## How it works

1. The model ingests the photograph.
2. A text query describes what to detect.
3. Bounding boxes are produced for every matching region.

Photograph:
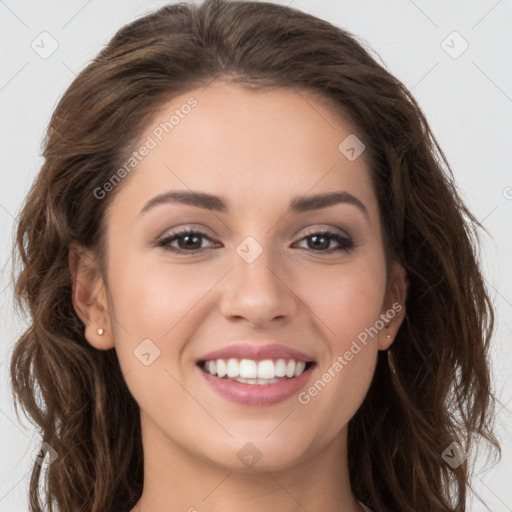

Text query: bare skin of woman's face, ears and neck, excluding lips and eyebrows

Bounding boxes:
[70,81,407,512]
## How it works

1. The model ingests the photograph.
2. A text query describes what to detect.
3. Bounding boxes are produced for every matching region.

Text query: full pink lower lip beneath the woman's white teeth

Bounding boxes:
[197,364,315,405]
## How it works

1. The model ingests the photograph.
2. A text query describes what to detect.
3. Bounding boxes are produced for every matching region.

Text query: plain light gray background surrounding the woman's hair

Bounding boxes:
[0,0,512,512]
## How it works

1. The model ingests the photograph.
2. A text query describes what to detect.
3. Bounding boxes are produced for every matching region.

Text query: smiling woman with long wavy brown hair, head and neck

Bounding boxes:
[11,0,498,512]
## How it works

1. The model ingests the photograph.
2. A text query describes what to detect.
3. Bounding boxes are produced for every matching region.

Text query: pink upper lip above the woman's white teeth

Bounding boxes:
[197,341,314,363]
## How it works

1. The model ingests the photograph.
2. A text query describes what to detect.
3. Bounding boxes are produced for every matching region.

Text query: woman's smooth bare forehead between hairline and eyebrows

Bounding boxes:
[106,81,375,220]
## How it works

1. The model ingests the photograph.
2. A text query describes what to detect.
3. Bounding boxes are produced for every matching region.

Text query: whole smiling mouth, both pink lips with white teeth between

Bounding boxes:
[197,341,315,405]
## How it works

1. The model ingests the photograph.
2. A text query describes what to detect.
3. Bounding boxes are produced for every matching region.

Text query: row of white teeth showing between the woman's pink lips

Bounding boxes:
[203,358,306,384]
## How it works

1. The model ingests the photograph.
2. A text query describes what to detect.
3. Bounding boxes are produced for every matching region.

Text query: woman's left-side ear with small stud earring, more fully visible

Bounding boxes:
[69,244,114,350]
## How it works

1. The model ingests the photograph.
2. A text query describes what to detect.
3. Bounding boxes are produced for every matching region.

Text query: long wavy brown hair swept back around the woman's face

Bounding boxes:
[11,0,499,512]
